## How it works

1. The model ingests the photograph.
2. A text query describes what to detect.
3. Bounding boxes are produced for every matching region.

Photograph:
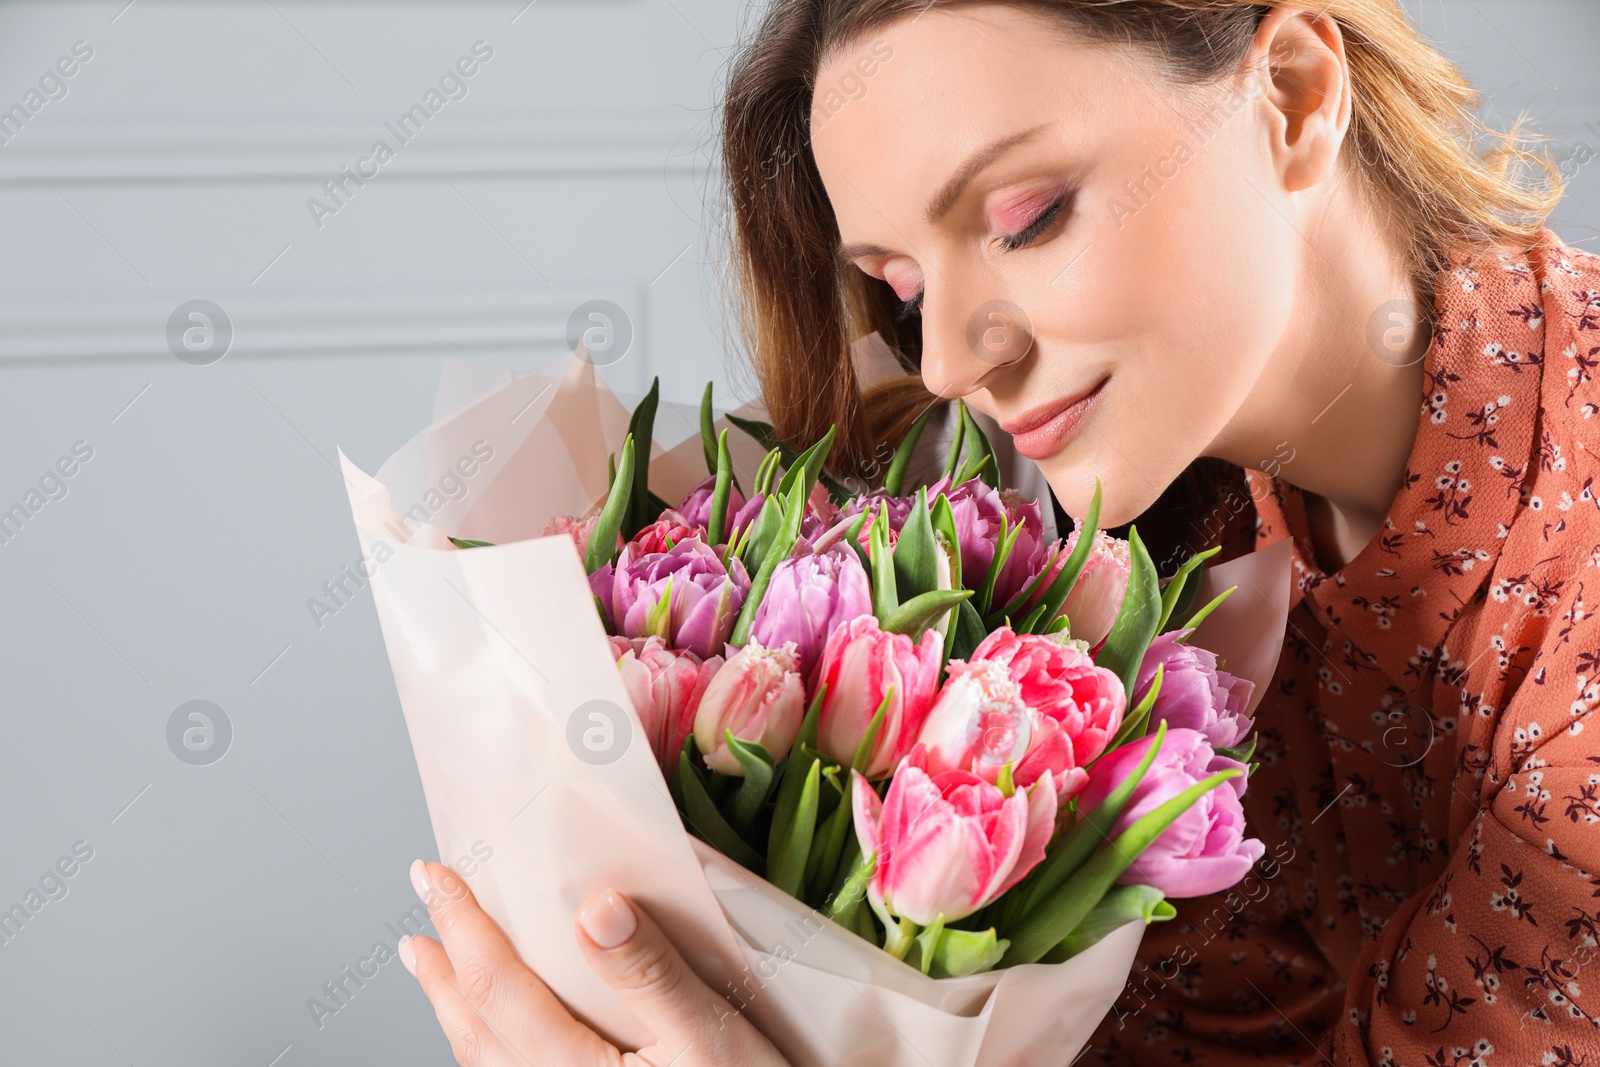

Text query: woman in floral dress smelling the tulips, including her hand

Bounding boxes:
[393,0,1600,1067]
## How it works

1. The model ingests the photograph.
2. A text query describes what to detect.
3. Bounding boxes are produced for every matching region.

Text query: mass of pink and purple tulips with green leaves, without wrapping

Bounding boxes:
[508,382,1264,977]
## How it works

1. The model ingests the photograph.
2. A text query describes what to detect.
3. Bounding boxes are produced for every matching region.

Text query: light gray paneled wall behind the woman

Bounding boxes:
[0,0,1600,1067]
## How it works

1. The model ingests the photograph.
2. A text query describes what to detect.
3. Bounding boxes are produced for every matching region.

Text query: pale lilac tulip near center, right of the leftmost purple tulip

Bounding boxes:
[750,541,872,680]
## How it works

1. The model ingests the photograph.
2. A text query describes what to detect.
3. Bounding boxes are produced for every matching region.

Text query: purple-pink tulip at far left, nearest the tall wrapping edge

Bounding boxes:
[589,537,750,659]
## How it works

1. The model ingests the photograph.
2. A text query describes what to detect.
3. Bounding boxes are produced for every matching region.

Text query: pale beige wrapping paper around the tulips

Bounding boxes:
[341,357,1288,1067]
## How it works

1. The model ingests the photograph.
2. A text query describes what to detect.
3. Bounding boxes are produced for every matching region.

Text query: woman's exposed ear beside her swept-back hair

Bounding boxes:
[1248,8,1350,192]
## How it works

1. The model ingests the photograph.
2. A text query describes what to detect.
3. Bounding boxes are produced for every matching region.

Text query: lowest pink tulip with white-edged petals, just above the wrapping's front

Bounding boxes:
[851,745,1056,926]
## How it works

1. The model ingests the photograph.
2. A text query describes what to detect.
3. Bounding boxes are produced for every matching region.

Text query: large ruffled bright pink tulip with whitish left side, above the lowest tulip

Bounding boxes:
[918,627,1126,803]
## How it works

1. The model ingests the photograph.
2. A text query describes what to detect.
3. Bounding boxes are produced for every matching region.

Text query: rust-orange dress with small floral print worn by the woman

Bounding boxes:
[1085,232,1600,1067]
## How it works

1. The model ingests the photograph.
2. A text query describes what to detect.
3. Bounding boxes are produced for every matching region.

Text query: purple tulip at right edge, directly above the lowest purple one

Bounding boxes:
[1128,630,1256,749]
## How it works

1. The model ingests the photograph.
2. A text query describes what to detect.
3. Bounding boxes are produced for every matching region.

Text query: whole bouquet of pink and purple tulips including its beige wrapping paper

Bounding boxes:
[344,352,1288,1067]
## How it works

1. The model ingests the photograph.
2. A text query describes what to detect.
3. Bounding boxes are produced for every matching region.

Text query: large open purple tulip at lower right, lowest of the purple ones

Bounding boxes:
[1078,729,1266,897]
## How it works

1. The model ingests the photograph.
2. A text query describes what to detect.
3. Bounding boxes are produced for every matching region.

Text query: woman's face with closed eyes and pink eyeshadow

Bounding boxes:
[811,3,1304,526]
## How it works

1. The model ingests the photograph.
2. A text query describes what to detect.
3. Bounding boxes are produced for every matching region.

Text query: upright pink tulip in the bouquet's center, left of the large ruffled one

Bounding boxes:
[818,614,944,779]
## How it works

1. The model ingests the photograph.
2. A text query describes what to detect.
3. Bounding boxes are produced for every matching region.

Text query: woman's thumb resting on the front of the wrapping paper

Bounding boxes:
[578,889,754,1064]
